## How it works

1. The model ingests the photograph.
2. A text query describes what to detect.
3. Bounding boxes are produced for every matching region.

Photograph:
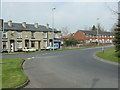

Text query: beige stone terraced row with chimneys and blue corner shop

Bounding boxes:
[2,21,61,52]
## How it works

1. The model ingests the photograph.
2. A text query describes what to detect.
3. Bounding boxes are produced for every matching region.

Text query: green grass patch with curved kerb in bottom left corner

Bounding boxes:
[2,59,27,88]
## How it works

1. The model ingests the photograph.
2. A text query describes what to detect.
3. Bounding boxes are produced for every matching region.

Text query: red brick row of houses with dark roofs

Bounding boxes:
[61,30,114,44]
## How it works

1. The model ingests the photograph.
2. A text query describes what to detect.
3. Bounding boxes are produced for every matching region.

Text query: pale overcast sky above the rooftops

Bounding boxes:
[2,2,117,32]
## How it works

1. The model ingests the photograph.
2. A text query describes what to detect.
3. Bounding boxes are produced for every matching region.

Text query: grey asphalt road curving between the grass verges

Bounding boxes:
[3,46,119,88]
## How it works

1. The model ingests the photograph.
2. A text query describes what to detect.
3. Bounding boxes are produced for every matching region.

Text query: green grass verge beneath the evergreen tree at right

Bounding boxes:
[96,48,118,63]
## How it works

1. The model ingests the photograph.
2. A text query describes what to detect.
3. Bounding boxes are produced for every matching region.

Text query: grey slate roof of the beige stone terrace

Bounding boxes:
[4,22,60,32]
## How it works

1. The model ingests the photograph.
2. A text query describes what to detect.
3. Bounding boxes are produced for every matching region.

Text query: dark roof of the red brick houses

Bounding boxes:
[79,30,114,35]
